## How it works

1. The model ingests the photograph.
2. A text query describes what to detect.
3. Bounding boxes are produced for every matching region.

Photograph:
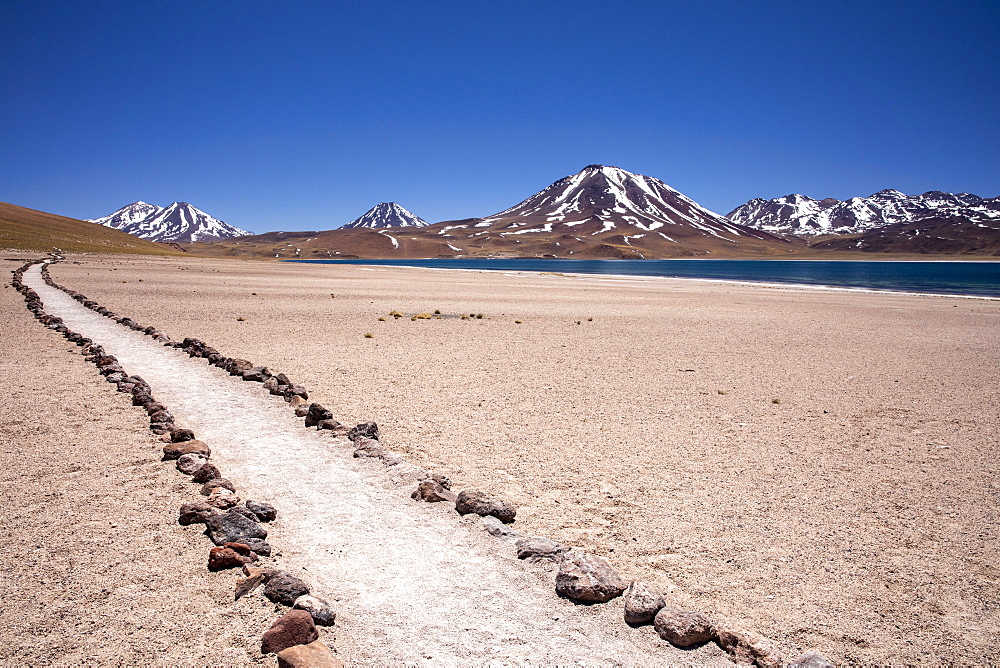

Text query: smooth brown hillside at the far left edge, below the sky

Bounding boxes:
[0,202,184,255]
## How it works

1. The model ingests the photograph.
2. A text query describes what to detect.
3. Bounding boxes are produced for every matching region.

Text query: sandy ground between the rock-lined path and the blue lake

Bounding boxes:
[5,253,1000,663]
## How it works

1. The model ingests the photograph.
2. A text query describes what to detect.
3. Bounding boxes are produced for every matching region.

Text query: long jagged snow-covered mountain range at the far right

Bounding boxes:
[727,190,1000,236]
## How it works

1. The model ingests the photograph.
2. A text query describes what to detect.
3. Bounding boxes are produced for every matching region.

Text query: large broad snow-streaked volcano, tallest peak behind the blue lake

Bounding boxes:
[458,165,772,245]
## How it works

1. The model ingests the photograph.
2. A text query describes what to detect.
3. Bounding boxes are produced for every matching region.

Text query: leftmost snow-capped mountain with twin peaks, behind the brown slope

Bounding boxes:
[90,202,250,242]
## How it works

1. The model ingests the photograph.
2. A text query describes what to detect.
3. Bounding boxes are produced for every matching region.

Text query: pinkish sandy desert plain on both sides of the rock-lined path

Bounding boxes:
[0,252,1000,664]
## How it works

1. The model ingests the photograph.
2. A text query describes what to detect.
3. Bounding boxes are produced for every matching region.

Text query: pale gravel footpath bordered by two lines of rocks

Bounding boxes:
[24,267,725,665]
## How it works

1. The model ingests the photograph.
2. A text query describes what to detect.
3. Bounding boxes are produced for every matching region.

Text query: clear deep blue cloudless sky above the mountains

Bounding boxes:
[0,0,1000,232]
